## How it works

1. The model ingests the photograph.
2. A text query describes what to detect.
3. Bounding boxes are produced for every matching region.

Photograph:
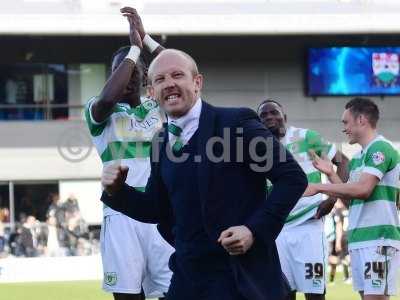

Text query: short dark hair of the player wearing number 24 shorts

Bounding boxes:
[345,97,379,128]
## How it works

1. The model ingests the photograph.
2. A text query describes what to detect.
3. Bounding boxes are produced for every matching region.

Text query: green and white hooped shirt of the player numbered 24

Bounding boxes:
[348,136,400,250]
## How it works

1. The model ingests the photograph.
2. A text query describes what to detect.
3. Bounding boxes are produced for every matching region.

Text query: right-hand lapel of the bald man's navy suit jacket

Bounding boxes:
[197,101,215,205]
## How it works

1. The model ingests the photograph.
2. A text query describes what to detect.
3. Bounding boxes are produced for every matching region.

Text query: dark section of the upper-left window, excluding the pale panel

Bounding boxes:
[0,63,68,120]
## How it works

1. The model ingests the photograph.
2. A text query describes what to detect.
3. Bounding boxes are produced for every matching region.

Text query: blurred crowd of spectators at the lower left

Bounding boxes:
[0,194,99,258]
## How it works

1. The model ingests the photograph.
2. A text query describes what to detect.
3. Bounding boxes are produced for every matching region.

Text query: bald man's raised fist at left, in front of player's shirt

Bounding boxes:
[101,164,129,195]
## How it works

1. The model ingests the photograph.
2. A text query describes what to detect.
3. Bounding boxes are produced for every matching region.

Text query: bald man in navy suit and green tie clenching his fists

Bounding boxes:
[102,43,307,300]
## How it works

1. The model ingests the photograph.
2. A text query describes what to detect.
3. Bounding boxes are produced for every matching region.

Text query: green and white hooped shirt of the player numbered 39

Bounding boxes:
[281,126,336,228]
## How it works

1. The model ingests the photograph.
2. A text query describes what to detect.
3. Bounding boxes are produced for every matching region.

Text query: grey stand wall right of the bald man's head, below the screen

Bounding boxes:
[199,61,400,142]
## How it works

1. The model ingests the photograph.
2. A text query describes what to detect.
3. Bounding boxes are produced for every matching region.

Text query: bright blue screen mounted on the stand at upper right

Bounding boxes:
[307,47,400,96]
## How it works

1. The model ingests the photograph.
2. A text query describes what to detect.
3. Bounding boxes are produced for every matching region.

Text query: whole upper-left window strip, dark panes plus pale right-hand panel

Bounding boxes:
[0,63,106,120]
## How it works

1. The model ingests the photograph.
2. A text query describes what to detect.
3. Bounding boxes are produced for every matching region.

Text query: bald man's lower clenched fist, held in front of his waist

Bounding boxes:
[218,225,254,255]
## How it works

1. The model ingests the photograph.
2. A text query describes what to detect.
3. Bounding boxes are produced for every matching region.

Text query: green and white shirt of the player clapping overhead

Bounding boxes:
[85,97,163,216]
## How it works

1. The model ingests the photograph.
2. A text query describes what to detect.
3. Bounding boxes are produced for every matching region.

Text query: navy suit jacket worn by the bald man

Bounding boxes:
[102,102,307,300]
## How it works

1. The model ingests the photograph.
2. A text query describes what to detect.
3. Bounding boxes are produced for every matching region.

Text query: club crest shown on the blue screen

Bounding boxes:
[372,52,400,87]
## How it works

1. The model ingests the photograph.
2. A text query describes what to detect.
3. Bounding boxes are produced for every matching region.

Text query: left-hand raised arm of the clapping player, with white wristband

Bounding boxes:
[92,10,143,123]
